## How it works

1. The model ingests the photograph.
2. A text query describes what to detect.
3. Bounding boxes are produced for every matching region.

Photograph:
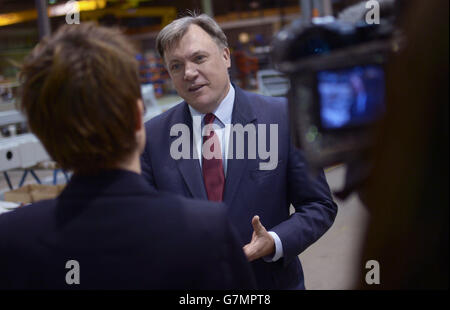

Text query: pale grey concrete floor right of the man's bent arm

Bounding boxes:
[299,167,369,290]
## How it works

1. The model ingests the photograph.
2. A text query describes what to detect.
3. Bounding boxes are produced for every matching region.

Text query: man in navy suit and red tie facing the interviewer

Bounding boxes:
[141,15,337,289]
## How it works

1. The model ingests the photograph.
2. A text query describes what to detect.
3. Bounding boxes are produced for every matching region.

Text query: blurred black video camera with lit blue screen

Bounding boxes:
[272,0,401,198]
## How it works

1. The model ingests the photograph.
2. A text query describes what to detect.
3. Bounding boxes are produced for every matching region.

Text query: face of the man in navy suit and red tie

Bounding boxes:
[164,25,231,113]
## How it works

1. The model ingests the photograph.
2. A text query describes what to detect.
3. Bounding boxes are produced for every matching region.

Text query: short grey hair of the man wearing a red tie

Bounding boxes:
[156,13,228,59]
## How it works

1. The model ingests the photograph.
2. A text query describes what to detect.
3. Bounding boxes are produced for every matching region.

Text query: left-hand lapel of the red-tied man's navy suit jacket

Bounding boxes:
[171,102,208,200]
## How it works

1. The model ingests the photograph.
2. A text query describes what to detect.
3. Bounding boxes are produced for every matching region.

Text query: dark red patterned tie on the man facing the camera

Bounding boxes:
[202,113,225,201]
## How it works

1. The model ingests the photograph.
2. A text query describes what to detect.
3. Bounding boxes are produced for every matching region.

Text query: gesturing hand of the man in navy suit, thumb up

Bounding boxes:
[243,215,275,262]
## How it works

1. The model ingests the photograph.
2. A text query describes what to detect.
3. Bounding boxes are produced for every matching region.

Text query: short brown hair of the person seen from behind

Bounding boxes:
[21,23,141,173]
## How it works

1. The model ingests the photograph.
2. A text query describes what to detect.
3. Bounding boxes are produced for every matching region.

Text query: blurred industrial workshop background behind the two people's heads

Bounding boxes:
[0,0,366,189]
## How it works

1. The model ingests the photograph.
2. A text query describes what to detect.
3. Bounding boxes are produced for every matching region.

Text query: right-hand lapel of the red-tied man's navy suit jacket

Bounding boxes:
[224,85,256,205]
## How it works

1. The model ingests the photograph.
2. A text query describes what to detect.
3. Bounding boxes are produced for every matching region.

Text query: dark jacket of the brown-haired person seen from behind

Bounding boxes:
[0,170,254,289]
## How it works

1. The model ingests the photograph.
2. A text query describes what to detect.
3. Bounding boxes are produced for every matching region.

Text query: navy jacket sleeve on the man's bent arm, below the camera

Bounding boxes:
[271,131,337,265]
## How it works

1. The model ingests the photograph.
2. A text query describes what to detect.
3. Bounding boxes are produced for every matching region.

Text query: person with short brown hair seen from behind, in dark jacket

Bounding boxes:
[0,23,254,289]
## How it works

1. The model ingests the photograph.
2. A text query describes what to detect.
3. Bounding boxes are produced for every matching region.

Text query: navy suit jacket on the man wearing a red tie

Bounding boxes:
[141,86,337,289]
